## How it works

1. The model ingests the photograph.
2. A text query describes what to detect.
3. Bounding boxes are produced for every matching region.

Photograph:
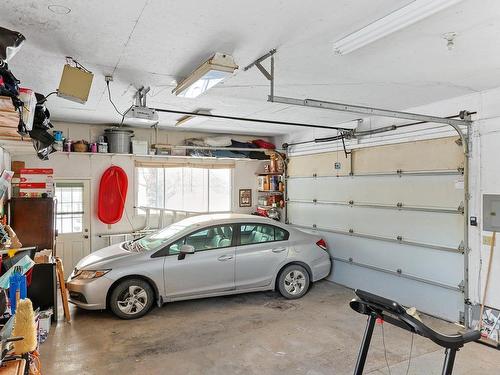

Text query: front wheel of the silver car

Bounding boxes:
[109,279,154,319]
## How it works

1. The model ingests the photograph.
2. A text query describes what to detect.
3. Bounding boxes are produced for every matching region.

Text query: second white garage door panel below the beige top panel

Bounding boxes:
[288,202,463,248]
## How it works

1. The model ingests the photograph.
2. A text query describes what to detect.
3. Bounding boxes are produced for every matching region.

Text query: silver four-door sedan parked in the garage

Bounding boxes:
[67,214,331,319]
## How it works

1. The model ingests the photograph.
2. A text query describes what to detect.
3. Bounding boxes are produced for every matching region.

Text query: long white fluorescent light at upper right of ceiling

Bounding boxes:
[333,0,462,55]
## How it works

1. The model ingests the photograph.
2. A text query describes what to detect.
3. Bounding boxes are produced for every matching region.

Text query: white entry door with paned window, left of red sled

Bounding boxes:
[55,180,90,276]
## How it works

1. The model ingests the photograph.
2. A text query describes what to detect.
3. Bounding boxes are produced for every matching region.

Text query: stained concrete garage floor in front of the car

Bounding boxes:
[41,281,500,375]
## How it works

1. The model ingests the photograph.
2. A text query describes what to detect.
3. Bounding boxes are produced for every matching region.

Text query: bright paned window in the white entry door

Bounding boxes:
[55,182,84,233]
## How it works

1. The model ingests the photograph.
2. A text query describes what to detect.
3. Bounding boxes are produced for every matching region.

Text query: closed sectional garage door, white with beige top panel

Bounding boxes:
[287,137,464,321]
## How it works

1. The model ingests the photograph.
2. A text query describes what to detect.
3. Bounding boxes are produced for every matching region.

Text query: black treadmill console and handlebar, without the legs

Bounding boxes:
[349,289,481,349]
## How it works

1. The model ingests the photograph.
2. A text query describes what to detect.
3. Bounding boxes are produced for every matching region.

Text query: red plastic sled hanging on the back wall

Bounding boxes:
[97,166,128,224]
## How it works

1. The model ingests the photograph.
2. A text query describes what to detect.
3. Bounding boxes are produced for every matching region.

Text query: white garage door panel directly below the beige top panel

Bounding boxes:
[288,175,463,209]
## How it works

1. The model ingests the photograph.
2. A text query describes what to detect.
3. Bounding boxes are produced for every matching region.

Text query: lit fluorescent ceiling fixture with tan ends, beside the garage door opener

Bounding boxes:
[172,53,238,98]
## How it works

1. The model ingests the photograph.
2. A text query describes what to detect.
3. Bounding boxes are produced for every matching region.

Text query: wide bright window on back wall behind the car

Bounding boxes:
[136,167,232,212]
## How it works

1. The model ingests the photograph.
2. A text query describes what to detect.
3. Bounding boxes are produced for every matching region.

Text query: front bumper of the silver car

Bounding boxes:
[66,276,113,310]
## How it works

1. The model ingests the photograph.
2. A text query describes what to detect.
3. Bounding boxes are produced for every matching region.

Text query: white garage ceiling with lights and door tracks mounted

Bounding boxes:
[0,0,500,135]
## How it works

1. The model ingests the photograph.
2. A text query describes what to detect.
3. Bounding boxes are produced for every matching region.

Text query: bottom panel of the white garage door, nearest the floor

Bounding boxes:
[332,262,463,321]
